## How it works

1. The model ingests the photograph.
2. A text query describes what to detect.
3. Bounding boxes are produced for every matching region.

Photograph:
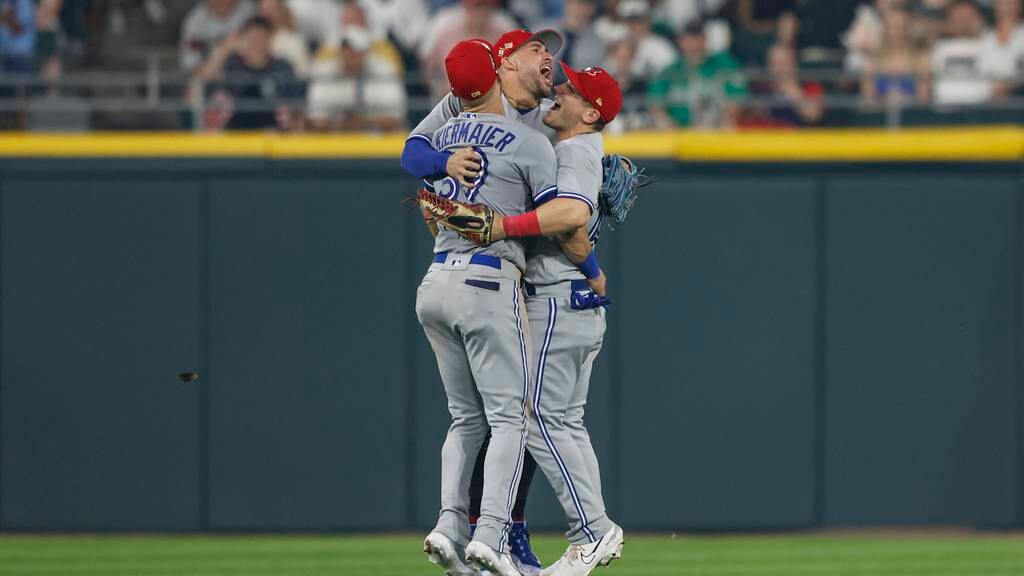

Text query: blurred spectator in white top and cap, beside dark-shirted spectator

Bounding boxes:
[309,27,406,130]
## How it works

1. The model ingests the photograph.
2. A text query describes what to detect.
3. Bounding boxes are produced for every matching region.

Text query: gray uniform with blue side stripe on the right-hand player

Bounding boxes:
[525,134,613,543]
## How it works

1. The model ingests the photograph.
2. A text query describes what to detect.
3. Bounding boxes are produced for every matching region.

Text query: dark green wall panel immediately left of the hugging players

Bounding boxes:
[210,176,411,530]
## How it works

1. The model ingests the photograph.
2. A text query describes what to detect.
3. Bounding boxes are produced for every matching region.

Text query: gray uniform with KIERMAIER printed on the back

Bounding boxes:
[416,113,556,552]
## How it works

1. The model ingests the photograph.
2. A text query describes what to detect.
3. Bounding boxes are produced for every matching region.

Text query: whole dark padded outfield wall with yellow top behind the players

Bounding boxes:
[0,128,1024,531]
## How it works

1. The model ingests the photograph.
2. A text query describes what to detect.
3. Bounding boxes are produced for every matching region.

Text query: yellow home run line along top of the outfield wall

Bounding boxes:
[0,126,1024,162]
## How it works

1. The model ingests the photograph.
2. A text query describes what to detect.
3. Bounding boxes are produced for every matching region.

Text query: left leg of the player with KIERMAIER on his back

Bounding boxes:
[417,272,487,575]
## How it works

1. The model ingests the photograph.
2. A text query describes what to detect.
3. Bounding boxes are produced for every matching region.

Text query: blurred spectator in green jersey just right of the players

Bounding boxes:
[647,23,746,128]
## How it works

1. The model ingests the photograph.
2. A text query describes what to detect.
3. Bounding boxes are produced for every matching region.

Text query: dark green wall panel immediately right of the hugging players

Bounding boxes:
[610,173,815,529]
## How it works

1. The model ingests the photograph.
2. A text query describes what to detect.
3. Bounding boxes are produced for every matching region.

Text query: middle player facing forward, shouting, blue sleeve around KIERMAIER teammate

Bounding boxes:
[401,30,565,576]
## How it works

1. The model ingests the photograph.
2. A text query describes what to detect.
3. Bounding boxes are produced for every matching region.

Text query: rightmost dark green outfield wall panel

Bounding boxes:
[824,171,1021,526]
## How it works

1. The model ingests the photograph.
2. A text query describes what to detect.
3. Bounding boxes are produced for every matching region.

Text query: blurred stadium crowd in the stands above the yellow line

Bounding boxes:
[0,0,1024,130]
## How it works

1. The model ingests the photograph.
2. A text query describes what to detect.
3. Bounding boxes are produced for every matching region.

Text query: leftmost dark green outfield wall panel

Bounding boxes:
[0,178,202,531]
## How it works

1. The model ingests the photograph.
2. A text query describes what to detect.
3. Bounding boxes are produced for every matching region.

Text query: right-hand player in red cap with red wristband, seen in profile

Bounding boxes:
[417,65,623,576]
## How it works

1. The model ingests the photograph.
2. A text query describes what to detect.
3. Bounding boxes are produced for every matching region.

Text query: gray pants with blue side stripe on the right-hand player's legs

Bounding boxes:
[527,297,614,544]
